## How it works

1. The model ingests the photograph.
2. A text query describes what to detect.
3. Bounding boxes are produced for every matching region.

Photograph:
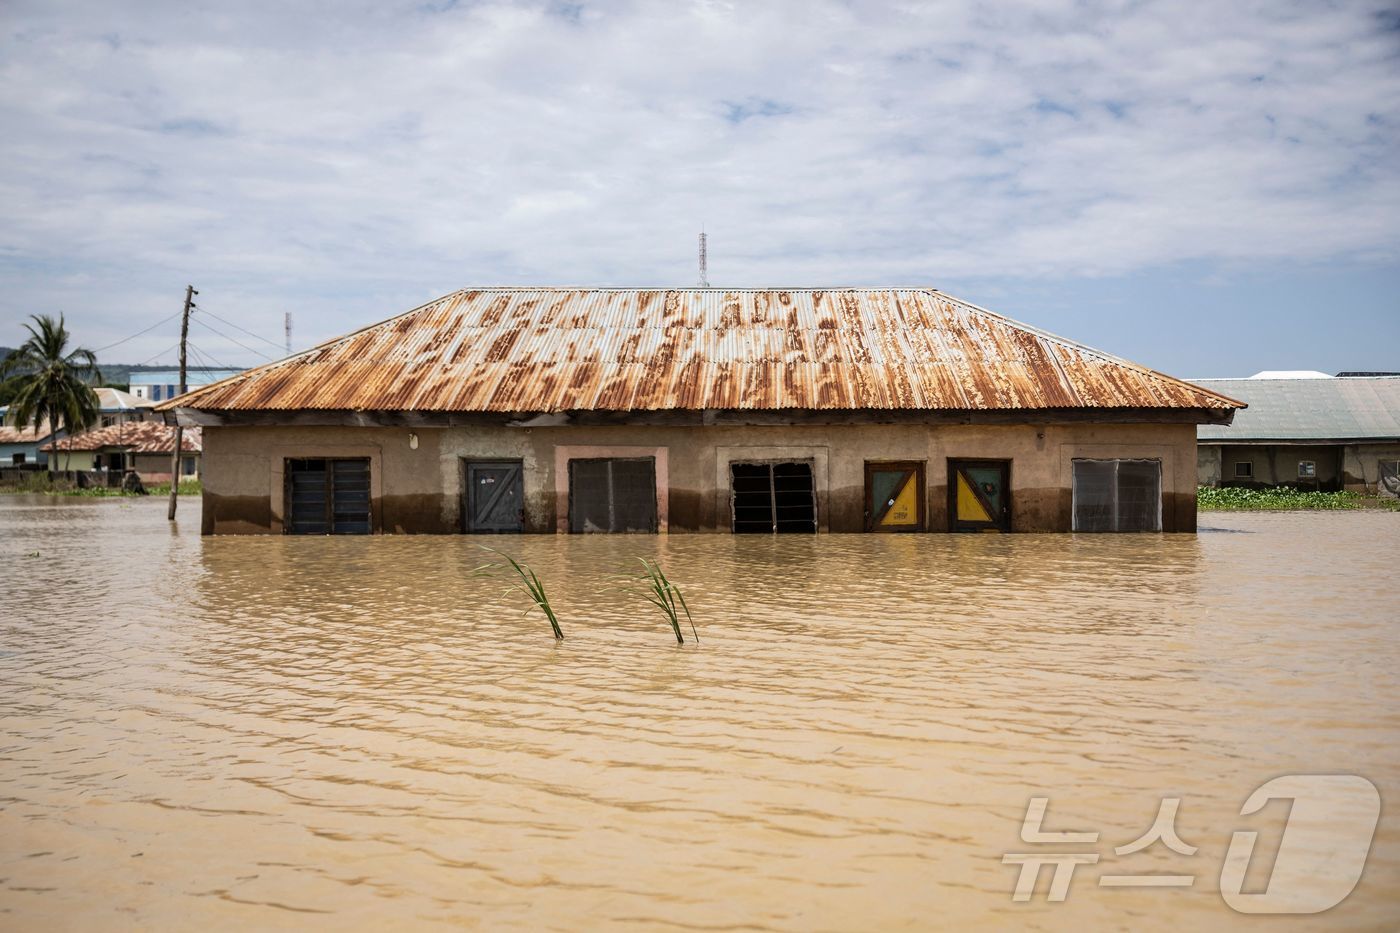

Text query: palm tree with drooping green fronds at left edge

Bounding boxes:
[0,314,102,471]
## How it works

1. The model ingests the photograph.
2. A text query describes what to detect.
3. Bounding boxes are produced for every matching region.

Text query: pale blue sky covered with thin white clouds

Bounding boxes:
[0,0,1400,377]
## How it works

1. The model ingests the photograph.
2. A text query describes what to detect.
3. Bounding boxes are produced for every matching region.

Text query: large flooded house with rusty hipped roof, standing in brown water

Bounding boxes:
[158,287,1242,534]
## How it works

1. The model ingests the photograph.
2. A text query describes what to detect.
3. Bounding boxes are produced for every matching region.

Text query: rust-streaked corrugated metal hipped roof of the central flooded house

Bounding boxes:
[160,289,1236,412]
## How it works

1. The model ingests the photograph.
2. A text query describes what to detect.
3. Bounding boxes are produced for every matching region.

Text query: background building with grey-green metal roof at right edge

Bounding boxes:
[1196,373,1400,496]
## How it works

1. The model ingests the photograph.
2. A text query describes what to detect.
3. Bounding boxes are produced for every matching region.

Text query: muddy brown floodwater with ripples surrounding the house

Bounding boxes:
[0,496,1400,930]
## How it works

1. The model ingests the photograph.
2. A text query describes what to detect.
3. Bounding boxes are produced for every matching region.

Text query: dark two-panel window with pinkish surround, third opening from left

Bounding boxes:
[568,457,657,534]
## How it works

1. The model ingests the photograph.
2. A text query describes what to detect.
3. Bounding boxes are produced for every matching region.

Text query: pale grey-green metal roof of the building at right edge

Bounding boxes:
[1197,375,1400,444]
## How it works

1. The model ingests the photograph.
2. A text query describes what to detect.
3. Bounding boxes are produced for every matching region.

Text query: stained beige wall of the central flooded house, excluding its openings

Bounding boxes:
[202,424,1197,534]
